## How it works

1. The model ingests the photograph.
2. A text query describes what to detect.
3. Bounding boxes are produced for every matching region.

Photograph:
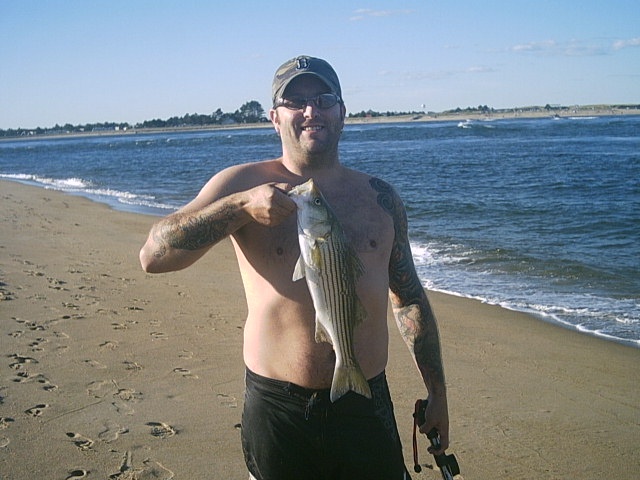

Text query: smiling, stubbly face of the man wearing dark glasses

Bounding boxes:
[269,75,345,158]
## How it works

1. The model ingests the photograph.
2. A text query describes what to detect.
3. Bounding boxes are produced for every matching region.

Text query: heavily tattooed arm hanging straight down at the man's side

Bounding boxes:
[371,179,449,453]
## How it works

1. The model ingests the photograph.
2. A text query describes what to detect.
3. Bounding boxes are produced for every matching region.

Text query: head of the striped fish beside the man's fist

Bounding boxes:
[289,179,335,238]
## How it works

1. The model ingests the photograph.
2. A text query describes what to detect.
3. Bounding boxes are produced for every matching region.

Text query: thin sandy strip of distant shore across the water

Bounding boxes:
[0,105,640,142]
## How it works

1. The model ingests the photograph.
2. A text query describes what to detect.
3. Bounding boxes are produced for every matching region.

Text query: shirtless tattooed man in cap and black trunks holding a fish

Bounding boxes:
[140,56,449,480]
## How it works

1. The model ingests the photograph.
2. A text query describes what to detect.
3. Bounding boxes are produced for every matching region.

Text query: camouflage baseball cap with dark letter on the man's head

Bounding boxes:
[271,55,342,105]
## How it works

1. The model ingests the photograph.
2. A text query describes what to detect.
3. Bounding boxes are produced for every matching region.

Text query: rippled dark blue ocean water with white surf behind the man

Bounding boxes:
[0,116,640,347]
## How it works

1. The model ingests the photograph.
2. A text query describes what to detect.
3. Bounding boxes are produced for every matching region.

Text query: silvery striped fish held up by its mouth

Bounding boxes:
[288,179,371,402]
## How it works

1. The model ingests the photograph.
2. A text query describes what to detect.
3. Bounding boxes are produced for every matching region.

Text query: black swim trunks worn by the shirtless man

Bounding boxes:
[242,369,409,480]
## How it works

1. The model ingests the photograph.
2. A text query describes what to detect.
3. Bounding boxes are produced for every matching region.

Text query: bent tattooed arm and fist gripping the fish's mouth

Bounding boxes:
[140,172,296,273]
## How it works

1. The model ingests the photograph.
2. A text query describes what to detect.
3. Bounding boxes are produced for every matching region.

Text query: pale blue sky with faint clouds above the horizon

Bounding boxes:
[0,0,640,129]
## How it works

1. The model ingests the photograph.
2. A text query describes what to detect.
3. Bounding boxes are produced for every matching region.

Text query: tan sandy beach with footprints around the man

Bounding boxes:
[0,181,640,480]
